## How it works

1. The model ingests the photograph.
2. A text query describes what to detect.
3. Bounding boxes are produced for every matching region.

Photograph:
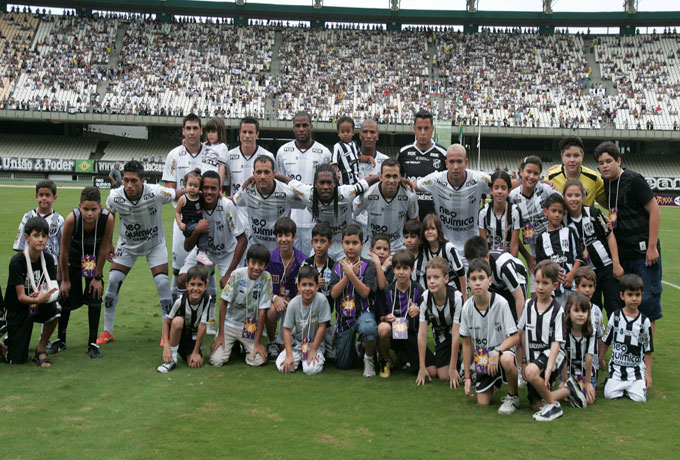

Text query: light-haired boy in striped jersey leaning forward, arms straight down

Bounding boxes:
[416,257,463,388]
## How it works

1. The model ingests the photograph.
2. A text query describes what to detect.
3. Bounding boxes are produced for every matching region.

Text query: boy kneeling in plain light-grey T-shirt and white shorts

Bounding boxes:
[276,265,331,375]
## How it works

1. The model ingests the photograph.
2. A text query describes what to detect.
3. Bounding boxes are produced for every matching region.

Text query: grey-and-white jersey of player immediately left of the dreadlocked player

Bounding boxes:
[234,180,305,251]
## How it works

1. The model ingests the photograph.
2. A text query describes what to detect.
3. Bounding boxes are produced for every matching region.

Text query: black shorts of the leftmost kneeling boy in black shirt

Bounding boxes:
[6,302,61,364]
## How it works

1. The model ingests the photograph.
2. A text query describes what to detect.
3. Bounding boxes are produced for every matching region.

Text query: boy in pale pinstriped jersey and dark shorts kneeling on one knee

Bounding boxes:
[460,259,519,414]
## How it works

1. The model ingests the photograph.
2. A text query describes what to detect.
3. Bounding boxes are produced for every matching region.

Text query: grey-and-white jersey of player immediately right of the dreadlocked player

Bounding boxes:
[355,182,418,254]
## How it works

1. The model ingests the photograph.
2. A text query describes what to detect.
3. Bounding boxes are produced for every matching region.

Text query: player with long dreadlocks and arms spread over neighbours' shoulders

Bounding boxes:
[276,163,378,259]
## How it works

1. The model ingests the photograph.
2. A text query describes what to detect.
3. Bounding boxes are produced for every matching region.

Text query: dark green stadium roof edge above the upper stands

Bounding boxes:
[9,0,680,27]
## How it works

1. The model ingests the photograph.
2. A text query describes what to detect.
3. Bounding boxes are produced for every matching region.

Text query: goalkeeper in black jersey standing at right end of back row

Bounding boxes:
[397,111,446,221]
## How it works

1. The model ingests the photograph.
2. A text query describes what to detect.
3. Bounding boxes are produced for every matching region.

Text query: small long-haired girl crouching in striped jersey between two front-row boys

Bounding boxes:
[562,292,597,409]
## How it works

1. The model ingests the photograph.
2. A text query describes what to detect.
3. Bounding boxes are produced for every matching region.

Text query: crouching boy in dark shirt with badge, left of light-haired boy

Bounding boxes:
[376,249,424,378]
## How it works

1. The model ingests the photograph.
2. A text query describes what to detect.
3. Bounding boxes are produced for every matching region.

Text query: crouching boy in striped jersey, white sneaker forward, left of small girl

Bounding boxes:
[517,260,569,422]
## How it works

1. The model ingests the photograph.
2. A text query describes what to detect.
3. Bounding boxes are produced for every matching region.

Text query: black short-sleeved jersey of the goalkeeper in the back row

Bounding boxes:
[397,142,446,220]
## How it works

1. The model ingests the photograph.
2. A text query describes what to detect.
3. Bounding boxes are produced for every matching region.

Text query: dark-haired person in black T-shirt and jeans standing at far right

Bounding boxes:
[595,142,663,334]
